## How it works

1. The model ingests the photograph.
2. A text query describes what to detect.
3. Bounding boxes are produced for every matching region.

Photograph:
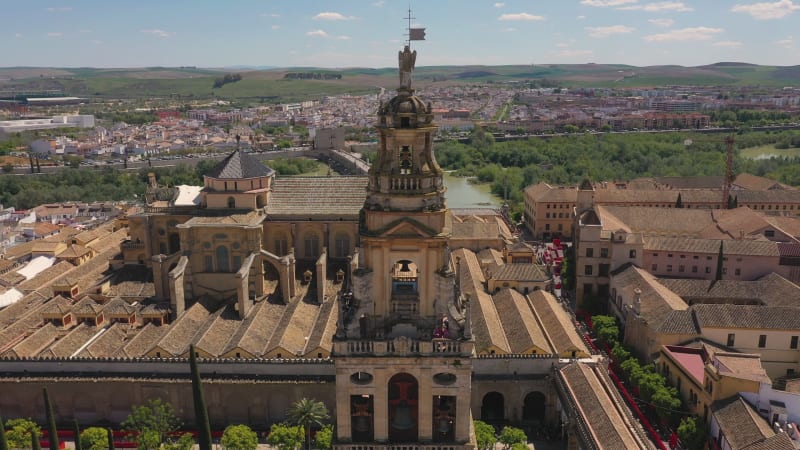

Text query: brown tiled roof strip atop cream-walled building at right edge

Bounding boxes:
[692,304,800,330]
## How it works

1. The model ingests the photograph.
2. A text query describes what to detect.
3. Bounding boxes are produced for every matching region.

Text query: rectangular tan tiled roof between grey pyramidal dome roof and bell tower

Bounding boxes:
[267,176,368,220]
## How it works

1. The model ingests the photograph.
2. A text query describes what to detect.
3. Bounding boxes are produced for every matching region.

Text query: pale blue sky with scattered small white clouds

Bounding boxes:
[6,0,800,67]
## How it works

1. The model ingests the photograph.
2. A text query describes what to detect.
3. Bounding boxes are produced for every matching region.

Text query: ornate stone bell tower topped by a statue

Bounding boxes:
[333,45,474,450]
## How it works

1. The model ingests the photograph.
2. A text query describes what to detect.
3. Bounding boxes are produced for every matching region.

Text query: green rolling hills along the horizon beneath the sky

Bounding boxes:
[0,62,800,102]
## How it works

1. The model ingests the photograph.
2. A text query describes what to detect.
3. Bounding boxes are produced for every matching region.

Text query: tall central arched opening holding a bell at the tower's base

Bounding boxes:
[388,373,419,442]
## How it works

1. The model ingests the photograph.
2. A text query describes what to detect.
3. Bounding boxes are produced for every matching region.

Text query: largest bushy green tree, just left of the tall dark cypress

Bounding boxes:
[122,399,181,448]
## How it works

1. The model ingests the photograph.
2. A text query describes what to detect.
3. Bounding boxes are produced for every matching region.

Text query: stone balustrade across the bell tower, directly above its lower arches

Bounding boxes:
[333,338,475,356]
